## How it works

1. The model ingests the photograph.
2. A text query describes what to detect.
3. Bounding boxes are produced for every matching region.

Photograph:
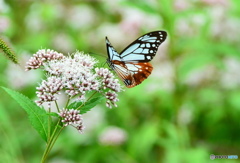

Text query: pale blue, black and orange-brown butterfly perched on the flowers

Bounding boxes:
[106,31,167,88]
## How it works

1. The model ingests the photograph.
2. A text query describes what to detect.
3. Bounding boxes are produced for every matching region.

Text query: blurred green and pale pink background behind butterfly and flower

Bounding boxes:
[0,0,240,163]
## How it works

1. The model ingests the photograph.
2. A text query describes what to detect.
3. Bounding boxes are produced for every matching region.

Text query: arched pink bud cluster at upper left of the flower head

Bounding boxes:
[25,49,64,71]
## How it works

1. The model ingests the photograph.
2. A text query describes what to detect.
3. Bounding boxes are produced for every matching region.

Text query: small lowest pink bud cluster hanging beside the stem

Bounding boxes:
[58,109,84,133]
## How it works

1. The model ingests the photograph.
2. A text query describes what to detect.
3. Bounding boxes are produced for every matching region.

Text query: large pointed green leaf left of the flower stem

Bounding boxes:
[2,87,49,141]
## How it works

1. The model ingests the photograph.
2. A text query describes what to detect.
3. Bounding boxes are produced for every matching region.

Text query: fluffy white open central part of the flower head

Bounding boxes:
[44,52,99,100]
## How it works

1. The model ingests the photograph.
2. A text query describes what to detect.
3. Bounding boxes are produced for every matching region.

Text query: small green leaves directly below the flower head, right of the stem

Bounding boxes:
[67,96,104,114]
